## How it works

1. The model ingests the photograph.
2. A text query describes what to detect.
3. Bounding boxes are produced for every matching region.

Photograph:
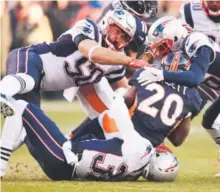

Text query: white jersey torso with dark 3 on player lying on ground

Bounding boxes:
[74,150,144,181]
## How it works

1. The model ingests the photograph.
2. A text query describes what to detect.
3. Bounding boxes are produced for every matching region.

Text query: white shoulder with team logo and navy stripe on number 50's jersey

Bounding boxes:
[64,19,99,41]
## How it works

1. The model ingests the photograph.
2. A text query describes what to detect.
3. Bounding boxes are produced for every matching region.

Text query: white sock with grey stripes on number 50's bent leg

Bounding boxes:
[0,73,35,97]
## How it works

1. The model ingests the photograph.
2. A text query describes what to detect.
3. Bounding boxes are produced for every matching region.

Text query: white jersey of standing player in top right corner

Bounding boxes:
[180,2,220,45]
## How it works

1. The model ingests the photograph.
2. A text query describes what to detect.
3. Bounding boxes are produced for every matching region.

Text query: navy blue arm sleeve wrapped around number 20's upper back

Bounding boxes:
[164,46,212,87]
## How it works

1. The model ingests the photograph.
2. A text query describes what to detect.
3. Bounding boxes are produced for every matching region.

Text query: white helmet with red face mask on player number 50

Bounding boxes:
[99,9,137,51]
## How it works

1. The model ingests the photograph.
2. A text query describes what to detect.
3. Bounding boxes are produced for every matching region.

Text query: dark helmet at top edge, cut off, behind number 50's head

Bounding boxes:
[120,0,158,18]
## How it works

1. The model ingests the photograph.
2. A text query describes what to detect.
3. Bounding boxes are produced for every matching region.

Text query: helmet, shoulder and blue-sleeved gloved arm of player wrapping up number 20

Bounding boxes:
[138,16,216,87]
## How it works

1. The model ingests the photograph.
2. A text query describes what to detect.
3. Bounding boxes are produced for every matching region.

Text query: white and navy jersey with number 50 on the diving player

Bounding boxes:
[34,19,125,91]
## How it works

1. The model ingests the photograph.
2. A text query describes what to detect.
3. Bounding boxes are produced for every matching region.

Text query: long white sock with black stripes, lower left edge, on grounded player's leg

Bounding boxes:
[0,99,27,177]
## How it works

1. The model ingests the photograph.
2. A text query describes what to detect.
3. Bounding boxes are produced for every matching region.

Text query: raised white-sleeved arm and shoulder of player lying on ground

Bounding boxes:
[109,96,153,172]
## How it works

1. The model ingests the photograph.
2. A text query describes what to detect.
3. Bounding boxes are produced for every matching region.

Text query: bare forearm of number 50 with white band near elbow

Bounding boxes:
[78,39,132,65]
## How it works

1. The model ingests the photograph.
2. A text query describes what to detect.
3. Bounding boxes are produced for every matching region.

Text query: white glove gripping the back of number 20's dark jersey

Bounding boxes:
[137,67,164,86]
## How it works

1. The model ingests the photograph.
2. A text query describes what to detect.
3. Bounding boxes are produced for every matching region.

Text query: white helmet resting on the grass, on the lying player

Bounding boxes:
[143,151,179,182]
